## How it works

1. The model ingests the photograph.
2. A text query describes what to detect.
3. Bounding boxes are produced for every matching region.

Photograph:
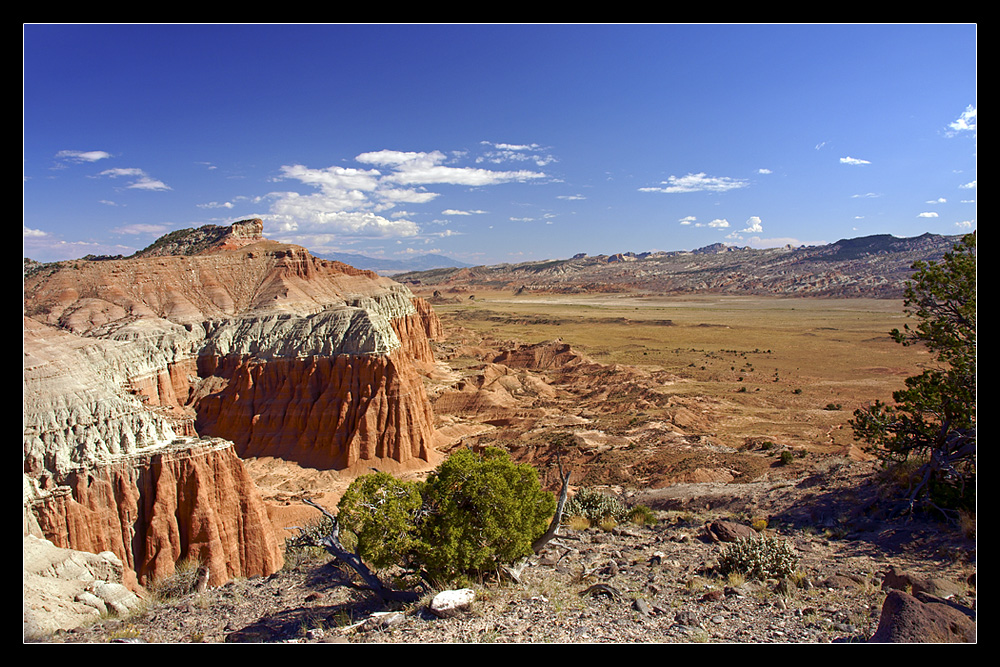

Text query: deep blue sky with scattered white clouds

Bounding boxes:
[23,24,977,264]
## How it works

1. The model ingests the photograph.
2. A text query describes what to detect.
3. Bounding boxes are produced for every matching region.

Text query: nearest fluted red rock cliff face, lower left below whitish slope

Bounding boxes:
[30,439,282,585]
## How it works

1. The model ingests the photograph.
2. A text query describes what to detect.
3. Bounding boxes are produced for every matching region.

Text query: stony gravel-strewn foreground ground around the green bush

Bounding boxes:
[37,461,976,643]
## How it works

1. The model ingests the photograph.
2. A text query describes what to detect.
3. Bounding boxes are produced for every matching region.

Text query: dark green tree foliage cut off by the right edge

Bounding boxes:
[851,234,976,507]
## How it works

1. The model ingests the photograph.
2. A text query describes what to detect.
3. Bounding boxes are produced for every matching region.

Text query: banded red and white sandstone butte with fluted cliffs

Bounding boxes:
[23,220,441,586]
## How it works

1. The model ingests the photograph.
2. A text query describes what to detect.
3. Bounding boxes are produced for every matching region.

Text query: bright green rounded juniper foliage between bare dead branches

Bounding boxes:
[338,448,556,581]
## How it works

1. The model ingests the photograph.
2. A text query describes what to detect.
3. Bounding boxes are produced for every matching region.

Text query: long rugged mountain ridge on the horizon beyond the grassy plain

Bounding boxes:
[394,233,961,298]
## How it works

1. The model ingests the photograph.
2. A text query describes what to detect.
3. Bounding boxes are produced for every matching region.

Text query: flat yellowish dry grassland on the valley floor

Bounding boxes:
[424,291,931,454]
